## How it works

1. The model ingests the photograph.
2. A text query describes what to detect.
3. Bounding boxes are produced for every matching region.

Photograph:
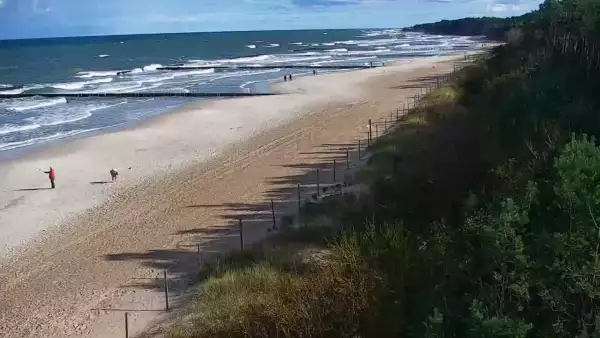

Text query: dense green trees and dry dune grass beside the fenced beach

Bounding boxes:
[173,0,600,338]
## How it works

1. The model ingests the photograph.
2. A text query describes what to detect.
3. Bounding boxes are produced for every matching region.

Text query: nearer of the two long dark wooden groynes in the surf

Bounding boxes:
[0,92,276,99]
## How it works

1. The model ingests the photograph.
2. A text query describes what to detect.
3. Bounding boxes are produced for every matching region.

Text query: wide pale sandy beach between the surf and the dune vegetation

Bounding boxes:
[0,57,460,338]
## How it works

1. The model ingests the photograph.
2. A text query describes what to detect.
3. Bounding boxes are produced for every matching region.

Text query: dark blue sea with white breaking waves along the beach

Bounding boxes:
[0,29,482,159]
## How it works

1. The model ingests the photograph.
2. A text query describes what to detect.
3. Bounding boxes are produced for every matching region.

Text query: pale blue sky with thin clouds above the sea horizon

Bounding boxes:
[0,0,542,39]
